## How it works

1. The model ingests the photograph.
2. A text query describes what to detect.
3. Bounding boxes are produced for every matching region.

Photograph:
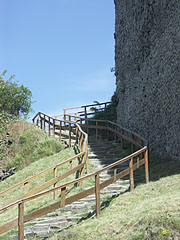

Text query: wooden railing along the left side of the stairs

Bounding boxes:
[0,112,88,213]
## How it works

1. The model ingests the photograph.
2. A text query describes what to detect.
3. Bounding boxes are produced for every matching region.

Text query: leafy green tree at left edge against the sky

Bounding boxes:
[0,70,32,117]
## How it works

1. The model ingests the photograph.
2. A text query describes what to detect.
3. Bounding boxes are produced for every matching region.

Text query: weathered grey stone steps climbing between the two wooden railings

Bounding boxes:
[12,139,129,239]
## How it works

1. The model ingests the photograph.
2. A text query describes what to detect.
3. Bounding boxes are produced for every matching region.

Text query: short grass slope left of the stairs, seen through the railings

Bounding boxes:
[0,143,94,239]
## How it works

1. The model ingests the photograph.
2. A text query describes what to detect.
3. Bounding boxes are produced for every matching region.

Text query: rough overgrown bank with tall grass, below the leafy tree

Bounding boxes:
[0,120,63,169]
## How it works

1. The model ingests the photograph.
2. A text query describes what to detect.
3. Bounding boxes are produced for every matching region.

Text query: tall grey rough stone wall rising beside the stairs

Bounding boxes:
[115,0,180,160]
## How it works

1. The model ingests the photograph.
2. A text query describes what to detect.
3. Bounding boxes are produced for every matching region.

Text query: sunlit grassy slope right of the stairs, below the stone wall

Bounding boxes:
[49,172,180,240]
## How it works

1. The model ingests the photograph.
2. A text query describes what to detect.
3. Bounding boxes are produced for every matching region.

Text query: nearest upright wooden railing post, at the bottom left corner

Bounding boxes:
[18,201,24,240]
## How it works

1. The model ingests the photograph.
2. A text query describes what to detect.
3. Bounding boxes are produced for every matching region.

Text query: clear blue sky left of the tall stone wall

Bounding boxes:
[0,0,115,119]
